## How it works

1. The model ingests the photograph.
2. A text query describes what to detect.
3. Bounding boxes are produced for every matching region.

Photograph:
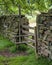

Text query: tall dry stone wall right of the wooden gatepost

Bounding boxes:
[37,11,52,59]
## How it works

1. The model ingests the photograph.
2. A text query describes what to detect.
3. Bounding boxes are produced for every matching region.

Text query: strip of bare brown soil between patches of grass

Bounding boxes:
[0,49,28,57]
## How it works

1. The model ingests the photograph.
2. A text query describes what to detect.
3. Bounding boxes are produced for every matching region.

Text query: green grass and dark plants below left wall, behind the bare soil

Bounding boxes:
[0,36,28,53]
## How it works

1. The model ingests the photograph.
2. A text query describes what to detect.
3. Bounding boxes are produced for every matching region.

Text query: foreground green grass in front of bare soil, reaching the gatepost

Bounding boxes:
[0,48,52,65]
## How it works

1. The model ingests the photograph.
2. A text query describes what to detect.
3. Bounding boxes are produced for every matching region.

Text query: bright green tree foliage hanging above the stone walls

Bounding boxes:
[0,0,52,15]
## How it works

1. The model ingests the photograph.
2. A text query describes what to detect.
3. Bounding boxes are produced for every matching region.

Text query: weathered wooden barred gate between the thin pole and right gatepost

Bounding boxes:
[22,23,35,48]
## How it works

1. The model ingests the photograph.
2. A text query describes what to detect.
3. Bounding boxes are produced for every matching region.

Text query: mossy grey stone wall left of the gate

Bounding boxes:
[0,15,28,42]
